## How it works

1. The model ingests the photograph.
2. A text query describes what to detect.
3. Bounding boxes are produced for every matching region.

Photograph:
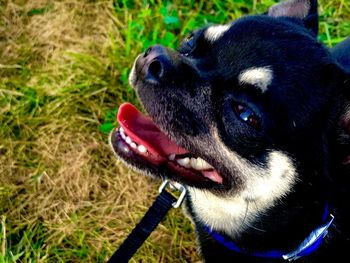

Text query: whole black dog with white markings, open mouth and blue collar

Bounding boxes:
[111,0,350,262]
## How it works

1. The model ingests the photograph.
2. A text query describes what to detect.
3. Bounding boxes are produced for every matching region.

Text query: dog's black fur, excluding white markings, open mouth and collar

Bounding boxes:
[112,0,350,262]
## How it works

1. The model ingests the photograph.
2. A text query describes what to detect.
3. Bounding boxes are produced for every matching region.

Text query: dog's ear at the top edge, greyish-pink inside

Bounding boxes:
[268,0,318,36]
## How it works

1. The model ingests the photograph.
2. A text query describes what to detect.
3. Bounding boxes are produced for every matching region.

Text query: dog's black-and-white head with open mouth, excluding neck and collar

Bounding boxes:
[111,0,348,235]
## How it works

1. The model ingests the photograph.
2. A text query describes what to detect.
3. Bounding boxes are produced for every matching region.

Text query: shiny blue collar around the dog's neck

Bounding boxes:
[205,204,334,261]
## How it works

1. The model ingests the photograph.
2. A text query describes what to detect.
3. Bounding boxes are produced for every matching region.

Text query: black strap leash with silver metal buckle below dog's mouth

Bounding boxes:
[107,180,186,263]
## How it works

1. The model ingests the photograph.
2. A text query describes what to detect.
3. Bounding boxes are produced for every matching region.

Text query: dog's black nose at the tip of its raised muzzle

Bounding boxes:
[143,45,172,82]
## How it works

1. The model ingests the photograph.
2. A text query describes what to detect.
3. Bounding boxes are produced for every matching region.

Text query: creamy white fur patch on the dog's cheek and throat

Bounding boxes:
[189,137,298,238]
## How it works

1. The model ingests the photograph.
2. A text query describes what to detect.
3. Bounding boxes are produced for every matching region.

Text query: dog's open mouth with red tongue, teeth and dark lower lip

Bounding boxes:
[111,103,223,185]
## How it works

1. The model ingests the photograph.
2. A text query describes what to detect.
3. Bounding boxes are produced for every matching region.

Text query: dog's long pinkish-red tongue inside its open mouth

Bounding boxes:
[117,103,188,157]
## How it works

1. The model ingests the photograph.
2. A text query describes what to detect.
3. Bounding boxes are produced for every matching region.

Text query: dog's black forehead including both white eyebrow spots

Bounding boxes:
[193,15,324,93]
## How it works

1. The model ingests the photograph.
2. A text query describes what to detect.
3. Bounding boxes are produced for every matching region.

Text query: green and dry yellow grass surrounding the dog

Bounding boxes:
[0,0,350,263]
